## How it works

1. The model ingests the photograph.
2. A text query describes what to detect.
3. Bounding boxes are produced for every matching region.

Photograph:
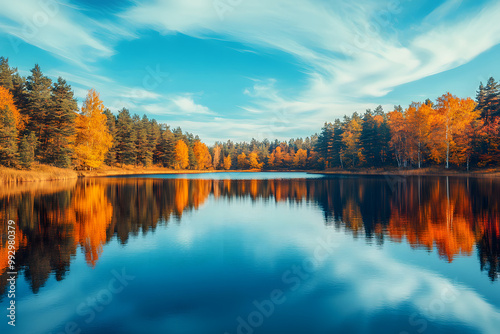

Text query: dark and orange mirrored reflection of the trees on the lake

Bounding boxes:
[0,177,500,293]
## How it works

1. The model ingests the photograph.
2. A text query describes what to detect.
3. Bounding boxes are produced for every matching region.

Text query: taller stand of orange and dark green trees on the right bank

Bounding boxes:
[317,78,500,169]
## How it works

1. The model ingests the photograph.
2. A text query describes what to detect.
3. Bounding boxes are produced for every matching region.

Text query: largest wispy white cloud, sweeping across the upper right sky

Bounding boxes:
[122,0,500,128]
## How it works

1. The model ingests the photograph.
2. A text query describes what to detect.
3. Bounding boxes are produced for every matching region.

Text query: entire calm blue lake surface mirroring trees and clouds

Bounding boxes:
[0,173,500,334]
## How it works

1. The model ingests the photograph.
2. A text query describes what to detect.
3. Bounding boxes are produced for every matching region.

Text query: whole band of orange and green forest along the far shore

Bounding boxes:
[0,57,500,170]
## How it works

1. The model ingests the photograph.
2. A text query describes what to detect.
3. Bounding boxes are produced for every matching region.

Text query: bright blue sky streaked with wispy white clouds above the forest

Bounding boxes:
[0,0,500,143]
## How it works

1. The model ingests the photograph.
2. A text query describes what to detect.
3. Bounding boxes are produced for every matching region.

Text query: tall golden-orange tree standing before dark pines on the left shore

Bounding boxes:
[75,89,113,169]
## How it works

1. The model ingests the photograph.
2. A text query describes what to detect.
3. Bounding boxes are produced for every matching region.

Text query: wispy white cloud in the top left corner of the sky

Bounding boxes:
[0,0,124,66]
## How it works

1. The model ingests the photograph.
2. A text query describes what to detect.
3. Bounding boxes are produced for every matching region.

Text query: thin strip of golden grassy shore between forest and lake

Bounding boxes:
[0,164,500,184]
